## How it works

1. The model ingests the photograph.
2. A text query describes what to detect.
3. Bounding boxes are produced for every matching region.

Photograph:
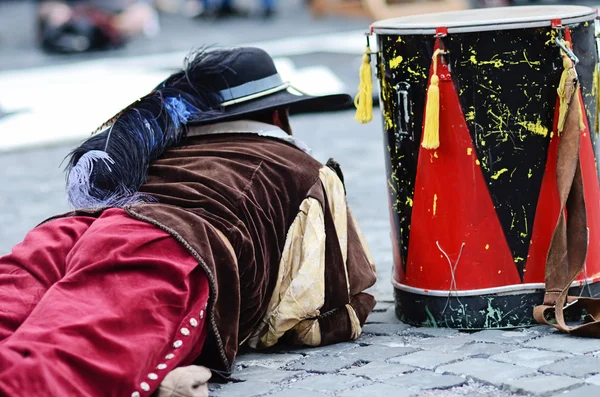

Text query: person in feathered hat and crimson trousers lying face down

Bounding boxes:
[0,48,376,397]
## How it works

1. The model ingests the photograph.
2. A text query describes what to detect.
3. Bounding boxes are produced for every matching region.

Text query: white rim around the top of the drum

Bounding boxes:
[371,5,597,35]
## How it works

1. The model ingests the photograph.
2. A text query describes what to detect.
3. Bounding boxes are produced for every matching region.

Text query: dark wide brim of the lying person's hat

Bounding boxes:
[187,87,354,125]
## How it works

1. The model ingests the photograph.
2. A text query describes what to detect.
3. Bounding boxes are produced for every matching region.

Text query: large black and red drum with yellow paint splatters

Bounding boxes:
[372,6,600,329]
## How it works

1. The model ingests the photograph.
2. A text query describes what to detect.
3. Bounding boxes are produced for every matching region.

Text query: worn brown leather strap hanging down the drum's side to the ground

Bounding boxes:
[533,74,600,337]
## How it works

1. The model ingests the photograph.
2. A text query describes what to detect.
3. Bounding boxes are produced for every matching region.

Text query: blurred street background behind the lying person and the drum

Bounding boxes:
[0,0,600,300]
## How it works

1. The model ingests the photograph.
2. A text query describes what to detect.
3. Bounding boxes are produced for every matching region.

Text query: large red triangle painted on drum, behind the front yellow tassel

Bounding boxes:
[404,58,521,291]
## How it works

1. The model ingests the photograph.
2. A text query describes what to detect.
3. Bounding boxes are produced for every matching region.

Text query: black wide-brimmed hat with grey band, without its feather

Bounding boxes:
[187,47,353,125]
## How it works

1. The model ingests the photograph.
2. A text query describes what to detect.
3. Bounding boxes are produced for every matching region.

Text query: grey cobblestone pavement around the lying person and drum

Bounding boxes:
[0,112,600,397]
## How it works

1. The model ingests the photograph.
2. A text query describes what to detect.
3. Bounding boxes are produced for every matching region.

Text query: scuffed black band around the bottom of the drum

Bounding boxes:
[394,282,600,330]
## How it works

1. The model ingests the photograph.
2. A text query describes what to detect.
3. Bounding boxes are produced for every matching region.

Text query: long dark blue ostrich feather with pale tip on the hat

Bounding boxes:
[65,50,239,208]
